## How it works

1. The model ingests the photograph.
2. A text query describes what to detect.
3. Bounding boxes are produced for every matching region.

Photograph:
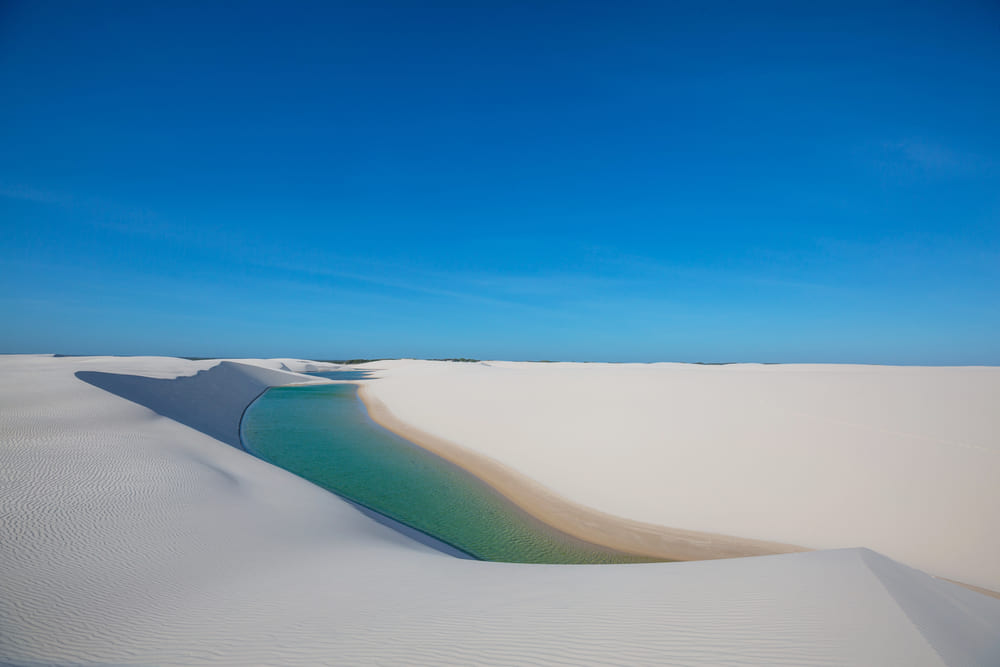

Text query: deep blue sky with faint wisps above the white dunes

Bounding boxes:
[0,0,1000,364]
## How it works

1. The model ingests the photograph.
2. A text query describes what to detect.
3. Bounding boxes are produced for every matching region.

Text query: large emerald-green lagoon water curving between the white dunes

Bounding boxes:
[242,384,653,563]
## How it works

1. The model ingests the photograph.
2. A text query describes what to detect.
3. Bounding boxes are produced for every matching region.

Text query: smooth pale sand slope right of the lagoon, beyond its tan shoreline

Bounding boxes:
[358,361,1000,590]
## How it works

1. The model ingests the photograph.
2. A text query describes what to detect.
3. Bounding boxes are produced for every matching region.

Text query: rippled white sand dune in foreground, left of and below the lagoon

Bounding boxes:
[0,356,1000,665]
